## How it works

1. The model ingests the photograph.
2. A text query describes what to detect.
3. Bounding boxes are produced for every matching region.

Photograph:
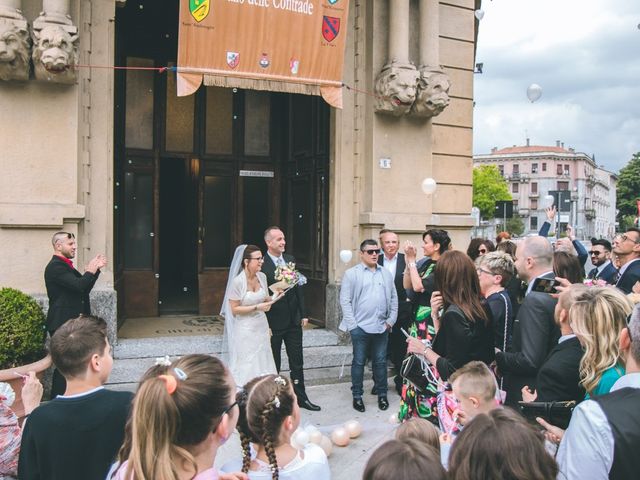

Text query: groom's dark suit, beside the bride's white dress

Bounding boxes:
[262,253,307,401]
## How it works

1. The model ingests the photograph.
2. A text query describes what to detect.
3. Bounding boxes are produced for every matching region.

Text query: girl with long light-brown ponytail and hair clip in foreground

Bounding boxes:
[108,354,244,480]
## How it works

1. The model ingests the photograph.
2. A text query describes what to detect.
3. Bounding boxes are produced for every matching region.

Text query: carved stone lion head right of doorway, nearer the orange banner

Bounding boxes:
[375,64,419,116]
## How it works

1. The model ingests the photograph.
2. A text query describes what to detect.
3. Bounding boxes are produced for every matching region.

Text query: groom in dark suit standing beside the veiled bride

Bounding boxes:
[262,226,320,411]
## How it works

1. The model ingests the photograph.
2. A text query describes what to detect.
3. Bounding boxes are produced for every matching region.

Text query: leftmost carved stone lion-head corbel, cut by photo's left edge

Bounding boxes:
[0,0,31,82]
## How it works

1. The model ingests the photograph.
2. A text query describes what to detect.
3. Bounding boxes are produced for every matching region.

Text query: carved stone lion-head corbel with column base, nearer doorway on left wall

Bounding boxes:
[32,0,79,84]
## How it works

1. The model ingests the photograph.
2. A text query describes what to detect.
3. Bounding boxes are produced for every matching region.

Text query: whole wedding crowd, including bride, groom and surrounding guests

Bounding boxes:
[0,225,640,480]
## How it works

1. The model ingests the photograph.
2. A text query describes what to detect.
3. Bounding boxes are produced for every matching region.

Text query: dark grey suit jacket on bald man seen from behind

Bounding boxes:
[496,274,560,405]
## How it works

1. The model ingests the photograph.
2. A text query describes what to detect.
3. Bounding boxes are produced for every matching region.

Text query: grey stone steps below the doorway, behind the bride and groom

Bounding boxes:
[107,344,352,389]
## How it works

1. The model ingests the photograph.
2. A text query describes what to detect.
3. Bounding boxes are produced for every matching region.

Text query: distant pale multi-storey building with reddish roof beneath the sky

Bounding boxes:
[473,139,617,239]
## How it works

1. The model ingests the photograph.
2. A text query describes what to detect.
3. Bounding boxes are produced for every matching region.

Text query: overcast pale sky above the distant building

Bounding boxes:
[474,0,640,172]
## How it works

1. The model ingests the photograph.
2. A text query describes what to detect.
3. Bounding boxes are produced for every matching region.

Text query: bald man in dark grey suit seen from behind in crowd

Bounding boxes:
[496,237,560,406]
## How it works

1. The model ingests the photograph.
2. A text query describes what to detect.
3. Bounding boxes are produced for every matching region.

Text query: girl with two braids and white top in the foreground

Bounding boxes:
[222,375,331,480]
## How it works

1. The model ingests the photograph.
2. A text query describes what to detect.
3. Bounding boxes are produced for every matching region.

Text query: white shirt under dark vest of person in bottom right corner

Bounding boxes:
[556,373,640,480]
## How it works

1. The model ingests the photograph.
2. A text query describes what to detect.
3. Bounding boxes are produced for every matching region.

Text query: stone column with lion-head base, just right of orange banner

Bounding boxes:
[375,0,419,117]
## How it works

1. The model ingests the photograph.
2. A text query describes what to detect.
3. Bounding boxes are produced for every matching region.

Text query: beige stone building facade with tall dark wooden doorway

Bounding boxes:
[0,0,480,339]
